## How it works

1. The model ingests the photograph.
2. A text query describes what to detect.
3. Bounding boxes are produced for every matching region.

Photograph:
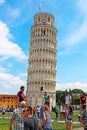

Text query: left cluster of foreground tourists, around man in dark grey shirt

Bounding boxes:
[9,86,52,130]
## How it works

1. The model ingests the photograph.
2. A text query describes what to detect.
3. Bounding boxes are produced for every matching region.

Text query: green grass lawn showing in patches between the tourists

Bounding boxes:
[0,111,81,130]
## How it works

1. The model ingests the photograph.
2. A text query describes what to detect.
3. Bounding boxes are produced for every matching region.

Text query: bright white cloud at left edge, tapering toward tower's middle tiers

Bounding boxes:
[0,21,27,60]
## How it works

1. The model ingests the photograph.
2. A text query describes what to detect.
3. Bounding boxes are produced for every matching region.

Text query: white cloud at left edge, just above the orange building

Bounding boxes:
[0,73,26,94]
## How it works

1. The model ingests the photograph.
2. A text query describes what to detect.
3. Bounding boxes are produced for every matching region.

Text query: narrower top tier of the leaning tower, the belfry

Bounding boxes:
[34,13,54,26]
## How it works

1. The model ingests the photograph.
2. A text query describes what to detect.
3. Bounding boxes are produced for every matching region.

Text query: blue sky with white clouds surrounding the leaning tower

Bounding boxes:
[0,0,87,94]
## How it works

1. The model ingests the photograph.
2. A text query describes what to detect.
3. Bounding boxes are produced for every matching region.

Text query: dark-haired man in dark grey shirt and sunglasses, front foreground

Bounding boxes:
[23,106,39,130]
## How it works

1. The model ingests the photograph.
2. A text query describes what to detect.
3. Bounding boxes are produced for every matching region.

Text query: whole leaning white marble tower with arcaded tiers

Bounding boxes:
[26,13,57,106]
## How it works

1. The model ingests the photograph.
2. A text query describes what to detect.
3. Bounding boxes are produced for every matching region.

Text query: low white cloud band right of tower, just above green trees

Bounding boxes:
[56,82,87,91]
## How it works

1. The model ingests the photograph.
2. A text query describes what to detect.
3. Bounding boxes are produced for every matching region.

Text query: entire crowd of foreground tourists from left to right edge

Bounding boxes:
[9,86,87,130]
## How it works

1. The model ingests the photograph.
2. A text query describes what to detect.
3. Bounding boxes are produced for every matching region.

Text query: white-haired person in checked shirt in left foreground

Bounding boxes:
[9,101,26,130]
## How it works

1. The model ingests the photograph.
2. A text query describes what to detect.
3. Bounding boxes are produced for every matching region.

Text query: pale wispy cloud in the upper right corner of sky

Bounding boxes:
[65,0,87,45]
